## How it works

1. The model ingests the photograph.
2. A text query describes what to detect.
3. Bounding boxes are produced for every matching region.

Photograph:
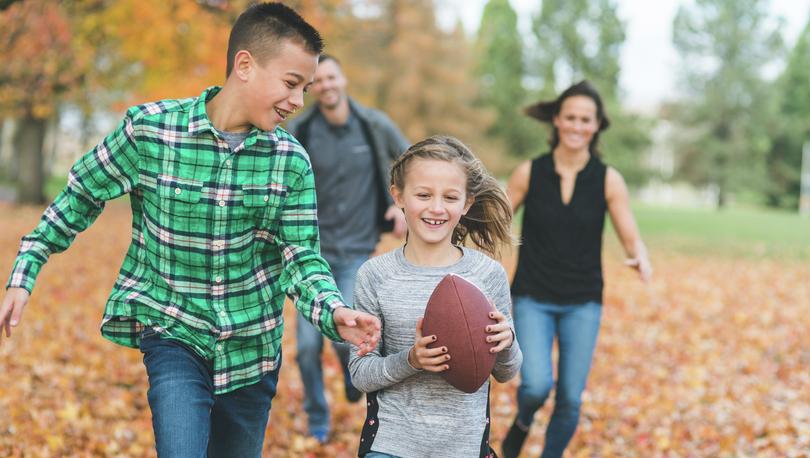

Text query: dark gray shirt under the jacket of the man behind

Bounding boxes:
[307,113,380,258]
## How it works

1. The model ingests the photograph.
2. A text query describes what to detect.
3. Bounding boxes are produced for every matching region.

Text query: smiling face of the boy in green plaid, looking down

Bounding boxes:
[235,40,318,132]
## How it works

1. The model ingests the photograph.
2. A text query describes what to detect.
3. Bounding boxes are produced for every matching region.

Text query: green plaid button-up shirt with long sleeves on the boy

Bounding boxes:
[8,87,344,393]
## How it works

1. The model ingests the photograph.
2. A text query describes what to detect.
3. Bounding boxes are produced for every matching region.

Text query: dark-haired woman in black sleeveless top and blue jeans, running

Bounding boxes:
[503,81,652,458]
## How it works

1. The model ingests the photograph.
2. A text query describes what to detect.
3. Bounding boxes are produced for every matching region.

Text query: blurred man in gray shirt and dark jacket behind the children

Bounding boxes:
[288,54,408,443]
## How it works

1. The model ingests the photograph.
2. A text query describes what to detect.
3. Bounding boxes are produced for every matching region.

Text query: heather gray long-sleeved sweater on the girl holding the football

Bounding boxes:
[349,248,523,458]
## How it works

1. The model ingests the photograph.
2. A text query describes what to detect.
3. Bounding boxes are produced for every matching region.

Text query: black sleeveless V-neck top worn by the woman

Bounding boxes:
[512,153,607,305]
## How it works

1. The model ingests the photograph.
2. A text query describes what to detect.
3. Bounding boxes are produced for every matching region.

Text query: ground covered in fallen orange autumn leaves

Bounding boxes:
[0,203,810,457]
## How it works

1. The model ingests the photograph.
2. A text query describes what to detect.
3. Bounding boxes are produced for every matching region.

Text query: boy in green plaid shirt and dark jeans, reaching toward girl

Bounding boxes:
[0,3,380,457]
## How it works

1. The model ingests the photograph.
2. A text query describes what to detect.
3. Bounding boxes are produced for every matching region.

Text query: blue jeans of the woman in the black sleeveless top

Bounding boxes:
[514,296,602,457]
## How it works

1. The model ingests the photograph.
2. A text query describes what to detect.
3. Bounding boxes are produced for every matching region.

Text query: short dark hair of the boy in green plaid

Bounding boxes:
[225,2,323,78]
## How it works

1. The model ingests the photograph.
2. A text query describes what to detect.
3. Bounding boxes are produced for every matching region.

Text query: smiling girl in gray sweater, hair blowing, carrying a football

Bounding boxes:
[349,136,523,458]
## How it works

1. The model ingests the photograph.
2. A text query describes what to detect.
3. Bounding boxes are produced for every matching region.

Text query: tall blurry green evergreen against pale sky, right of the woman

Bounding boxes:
[673,0,782,207]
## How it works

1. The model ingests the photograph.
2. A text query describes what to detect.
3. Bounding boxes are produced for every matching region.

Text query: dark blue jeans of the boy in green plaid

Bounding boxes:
[140,328,278,458]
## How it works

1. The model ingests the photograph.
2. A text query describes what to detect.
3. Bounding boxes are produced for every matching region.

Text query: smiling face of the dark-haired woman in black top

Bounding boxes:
[553,95,599,151]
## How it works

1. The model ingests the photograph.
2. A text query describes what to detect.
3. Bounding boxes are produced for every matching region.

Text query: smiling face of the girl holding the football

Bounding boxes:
[391,158,473,248]
